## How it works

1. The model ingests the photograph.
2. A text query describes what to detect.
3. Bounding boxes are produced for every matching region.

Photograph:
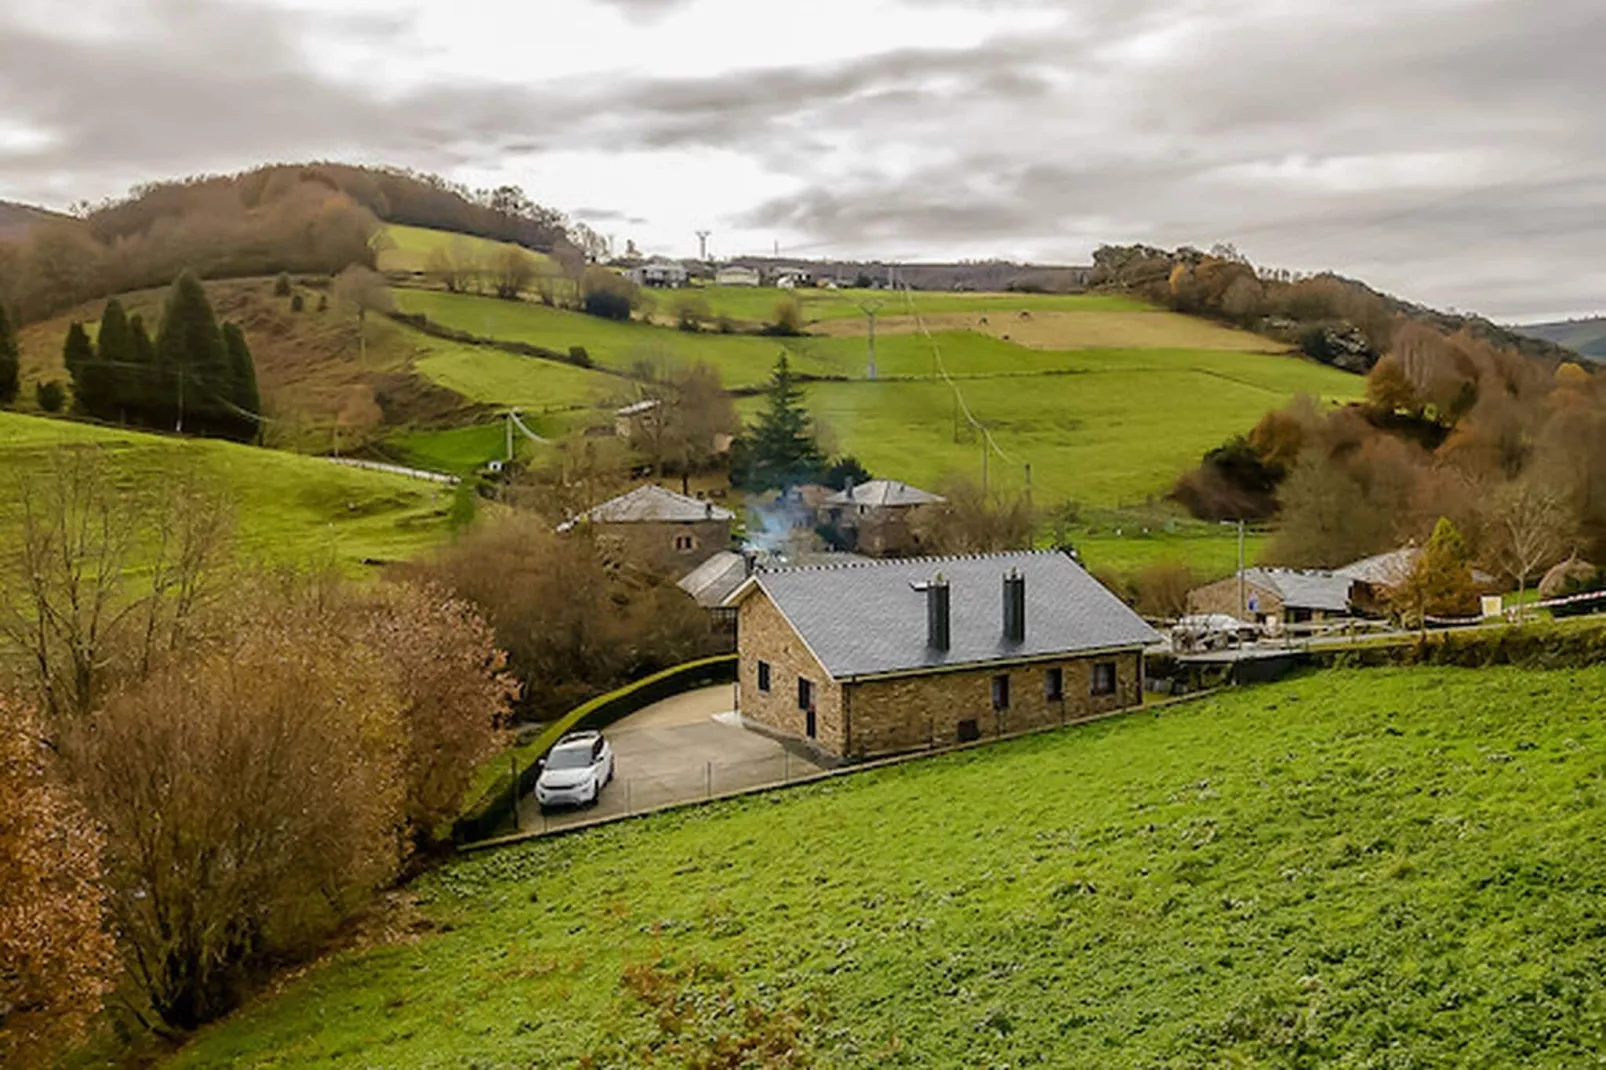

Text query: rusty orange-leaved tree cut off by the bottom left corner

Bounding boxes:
[0,699,116,1067]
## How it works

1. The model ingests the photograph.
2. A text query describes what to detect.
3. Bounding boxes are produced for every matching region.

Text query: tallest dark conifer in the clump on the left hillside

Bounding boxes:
[156,272,233,434]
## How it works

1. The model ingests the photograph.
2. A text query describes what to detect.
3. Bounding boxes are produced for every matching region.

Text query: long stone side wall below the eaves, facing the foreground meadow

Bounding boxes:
[843,651,1143,758]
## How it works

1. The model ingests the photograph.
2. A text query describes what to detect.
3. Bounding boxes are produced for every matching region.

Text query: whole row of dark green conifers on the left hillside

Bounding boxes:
[63,272,262,442]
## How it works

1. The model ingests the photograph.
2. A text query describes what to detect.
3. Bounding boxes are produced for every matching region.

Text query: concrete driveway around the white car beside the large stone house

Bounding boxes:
[519,684,824,832]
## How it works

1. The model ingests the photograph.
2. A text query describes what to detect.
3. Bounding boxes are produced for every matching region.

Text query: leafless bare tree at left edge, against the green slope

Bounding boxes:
[0,448,233,717]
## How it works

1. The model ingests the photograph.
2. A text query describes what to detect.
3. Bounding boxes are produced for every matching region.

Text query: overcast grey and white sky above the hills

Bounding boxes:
[0,0,1606,320]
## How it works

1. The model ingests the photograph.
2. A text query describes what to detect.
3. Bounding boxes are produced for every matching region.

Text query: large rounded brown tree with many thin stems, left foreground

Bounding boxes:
[63,585,406,1033]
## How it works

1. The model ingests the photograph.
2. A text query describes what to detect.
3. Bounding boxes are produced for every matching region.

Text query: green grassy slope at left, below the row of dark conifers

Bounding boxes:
[0,413,451,569]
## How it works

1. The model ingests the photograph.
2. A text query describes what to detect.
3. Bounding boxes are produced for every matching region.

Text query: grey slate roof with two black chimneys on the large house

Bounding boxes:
[726,551,1160,680]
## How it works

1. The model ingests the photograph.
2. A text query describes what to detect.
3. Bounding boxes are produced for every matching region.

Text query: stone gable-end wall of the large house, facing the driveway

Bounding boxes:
[736,591,848,755]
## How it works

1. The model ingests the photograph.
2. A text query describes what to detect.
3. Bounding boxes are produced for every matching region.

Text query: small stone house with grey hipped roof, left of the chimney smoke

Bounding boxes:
[557,484,736,575]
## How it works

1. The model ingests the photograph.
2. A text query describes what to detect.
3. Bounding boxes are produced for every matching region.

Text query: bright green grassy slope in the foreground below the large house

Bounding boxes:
[173,668,1606,1068]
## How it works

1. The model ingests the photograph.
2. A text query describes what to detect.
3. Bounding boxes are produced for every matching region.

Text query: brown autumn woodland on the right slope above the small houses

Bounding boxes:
[1174,323,1606,602]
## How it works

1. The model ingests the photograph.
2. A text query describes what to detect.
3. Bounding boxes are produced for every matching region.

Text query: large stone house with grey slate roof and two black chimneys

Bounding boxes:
[726,551,1160,760]
